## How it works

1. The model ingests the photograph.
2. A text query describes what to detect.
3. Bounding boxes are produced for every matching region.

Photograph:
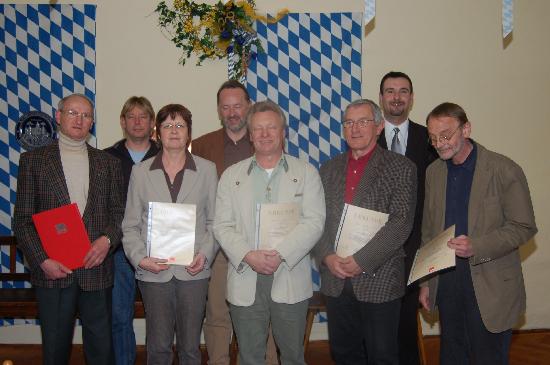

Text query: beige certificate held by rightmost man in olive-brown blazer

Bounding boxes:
[407,225,456,285]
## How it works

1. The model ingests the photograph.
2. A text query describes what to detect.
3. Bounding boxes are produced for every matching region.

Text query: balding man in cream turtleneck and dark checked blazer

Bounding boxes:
[14,94,124,365]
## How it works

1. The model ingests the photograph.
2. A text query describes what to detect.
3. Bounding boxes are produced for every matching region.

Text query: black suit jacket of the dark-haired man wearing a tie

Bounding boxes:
[378,120,437,279]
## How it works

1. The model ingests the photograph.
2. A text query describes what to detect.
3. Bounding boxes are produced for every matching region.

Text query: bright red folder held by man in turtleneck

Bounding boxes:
[32,203,91,270]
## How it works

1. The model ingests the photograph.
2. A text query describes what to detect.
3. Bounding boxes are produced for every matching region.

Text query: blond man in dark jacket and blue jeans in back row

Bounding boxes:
[105,96,159,365]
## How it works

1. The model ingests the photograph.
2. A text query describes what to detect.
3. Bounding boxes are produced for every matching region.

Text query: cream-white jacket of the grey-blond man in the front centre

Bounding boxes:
[214,155,325,306]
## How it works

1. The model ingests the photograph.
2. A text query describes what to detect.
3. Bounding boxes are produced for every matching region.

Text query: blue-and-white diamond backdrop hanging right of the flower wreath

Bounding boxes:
[246,13,362,318]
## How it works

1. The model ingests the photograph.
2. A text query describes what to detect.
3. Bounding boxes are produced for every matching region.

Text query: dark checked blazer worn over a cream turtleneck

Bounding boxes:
[13,142,124,290]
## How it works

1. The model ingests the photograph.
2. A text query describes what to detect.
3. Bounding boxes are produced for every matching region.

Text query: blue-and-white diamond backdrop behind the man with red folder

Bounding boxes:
[0,4,96,325]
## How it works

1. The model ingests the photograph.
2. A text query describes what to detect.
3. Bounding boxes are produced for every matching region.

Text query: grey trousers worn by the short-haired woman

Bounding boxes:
[138,278,208,365]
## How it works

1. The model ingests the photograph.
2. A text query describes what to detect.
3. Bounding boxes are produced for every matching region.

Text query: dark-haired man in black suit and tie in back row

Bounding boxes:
[378,71,437,365]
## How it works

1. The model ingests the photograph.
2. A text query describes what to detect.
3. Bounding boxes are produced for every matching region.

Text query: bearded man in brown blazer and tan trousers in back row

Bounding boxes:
[191,80,278,365]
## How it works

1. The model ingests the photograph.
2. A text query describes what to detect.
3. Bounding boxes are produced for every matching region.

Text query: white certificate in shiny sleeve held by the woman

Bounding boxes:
[147,202,197,265]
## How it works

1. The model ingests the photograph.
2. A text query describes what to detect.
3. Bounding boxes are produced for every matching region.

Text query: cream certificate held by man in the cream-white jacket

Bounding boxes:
[256,203,300,250]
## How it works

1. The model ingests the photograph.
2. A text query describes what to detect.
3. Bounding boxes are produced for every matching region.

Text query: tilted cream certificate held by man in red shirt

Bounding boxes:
[334,203,389,257]
